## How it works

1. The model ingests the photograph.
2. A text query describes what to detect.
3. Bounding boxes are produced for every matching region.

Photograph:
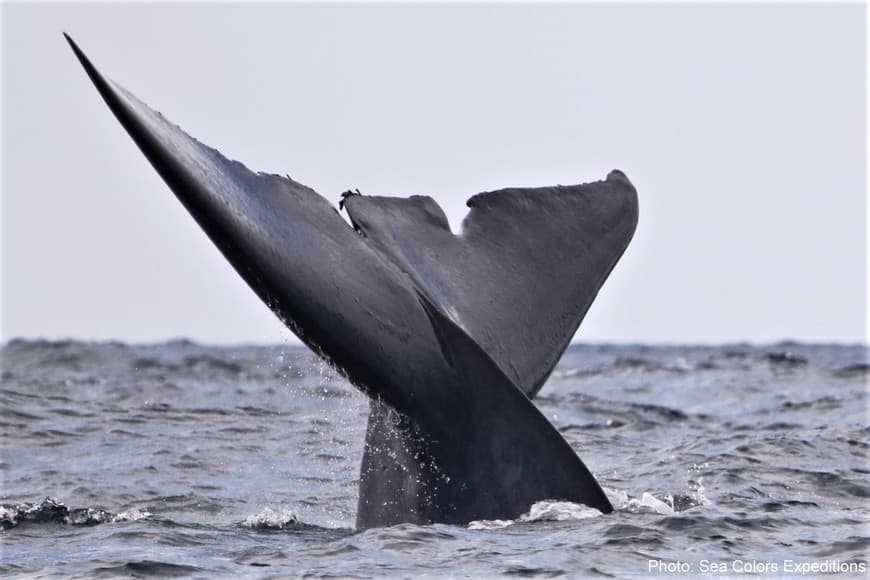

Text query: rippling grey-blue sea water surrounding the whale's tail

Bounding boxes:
[0,341,870,577]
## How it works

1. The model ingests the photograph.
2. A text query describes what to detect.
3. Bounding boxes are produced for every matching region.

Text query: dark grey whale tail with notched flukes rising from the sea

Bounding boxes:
[67,37,637,528]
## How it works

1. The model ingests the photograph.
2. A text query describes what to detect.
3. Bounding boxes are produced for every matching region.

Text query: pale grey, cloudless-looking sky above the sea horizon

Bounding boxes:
[2,2,867,343]
